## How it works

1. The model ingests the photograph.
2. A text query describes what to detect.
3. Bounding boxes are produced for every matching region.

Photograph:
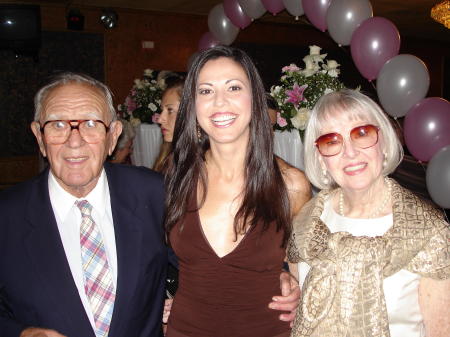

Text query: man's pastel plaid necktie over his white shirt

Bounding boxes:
[75,200,116,337]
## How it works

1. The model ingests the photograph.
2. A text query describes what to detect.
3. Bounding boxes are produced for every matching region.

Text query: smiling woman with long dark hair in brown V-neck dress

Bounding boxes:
[166,46,310,337]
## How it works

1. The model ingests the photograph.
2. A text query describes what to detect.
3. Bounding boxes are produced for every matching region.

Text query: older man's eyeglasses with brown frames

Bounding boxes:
[41,119,109,145]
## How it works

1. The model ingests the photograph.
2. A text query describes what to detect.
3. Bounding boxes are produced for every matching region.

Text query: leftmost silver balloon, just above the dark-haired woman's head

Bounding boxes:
[208,4,239,46]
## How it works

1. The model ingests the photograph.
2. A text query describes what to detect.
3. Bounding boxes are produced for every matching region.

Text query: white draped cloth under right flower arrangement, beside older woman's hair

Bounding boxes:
[274,130,305,171]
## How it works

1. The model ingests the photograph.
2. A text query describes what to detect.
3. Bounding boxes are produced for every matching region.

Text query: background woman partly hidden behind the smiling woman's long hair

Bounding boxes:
[153,76,184,173]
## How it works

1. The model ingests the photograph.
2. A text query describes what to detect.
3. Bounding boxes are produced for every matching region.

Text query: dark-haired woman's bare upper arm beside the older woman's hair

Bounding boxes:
[277,157,311,216]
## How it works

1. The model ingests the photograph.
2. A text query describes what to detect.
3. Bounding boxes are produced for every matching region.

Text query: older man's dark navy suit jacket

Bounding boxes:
[0,164,167,337]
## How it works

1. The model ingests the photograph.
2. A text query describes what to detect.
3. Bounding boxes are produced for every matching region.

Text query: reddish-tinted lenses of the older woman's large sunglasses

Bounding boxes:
[315,124,380,157]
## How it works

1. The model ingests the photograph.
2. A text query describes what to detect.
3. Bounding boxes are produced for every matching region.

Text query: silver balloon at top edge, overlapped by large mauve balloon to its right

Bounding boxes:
[327,0,373,46]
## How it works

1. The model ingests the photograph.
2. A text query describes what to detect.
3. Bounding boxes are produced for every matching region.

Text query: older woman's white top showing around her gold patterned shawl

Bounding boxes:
[298,200,425,337]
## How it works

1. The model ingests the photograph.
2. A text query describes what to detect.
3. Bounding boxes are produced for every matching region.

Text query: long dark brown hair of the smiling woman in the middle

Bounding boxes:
[166,46,291,245]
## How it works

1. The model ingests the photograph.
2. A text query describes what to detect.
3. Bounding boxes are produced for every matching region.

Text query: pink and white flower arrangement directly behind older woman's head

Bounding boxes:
[270,46,344,138]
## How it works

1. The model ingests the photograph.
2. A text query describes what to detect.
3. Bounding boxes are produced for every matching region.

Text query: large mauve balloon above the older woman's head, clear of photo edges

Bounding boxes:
[350,17,400,81]
